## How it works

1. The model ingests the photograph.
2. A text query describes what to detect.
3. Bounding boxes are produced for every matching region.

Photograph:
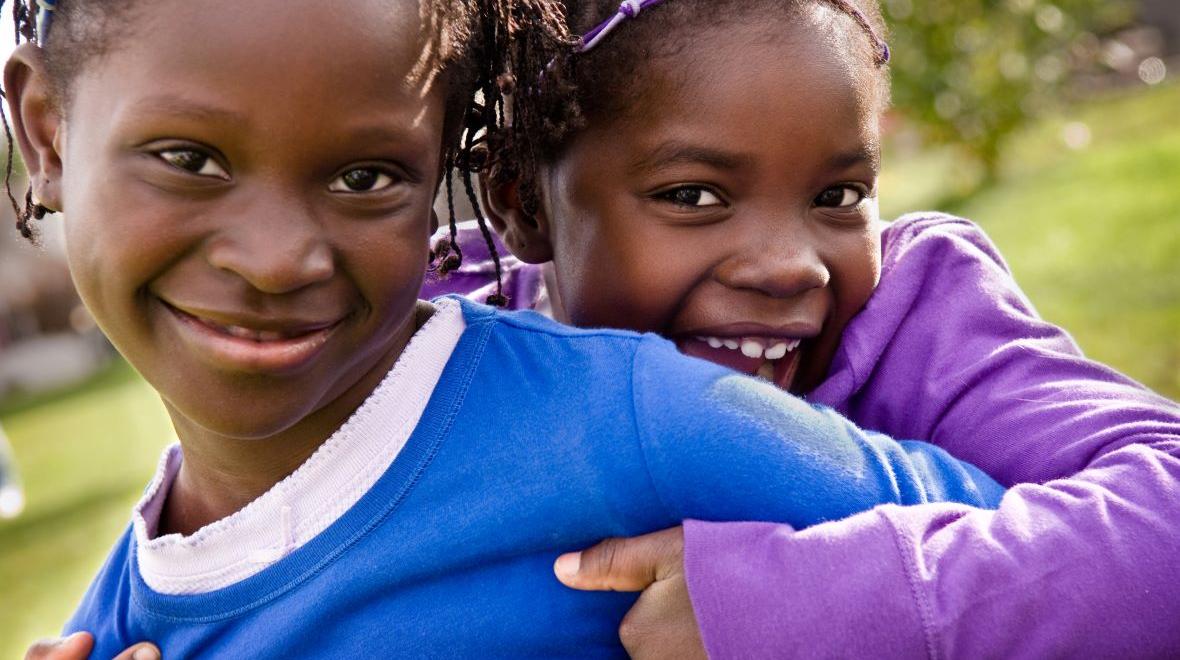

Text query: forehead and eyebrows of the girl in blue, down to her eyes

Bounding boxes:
[67,0,455,168]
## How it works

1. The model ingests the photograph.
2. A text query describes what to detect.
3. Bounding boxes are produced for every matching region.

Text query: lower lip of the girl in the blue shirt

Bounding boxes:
[164,303,339,373]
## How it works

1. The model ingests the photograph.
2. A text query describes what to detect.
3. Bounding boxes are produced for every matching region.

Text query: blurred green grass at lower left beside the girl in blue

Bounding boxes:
[0,362,171,658]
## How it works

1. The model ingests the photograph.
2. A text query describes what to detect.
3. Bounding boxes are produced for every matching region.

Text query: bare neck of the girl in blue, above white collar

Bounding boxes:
[158,302,434,536]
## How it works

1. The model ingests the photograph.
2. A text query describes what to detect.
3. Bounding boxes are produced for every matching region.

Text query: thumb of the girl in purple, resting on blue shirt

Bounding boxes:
[553,527,684,592]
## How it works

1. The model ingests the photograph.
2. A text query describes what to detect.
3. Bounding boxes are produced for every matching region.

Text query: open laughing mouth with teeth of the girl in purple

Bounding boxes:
[676,336,804,390]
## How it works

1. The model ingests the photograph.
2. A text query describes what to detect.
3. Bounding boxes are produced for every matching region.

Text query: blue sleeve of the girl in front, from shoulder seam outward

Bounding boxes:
[634,338,1003,528]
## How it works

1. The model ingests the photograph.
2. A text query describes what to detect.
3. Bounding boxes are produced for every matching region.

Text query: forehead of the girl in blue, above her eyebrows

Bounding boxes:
[70,0,446,108]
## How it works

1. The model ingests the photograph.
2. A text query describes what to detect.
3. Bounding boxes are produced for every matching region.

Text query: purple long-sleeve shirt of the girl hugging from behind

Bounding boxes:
[427,215,1180,658]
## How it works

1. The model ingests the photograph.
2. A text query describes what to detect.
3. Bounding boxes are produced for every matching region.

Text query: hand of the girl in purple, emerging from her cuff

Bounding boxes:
[553,527,707,659]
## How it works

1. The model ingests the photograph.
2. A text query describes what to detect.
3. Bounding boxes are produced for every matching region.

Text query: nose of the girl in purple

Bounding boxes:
[715,220,831,298]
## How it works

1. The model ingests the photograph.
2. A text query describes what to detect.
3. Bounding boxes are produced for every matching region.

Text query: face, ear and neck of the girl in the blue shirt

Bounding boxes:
[5,0,444,534]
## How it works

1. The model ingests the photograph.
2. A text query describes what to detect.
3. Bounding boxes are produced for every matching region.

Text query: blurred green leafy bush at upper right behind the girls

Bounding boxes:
[881,0,1135,181]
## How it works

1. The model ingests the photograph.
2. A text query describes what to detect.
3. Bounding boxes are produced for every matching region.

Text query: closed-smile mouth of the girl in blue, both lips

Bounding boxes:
[160,300,342,372]
